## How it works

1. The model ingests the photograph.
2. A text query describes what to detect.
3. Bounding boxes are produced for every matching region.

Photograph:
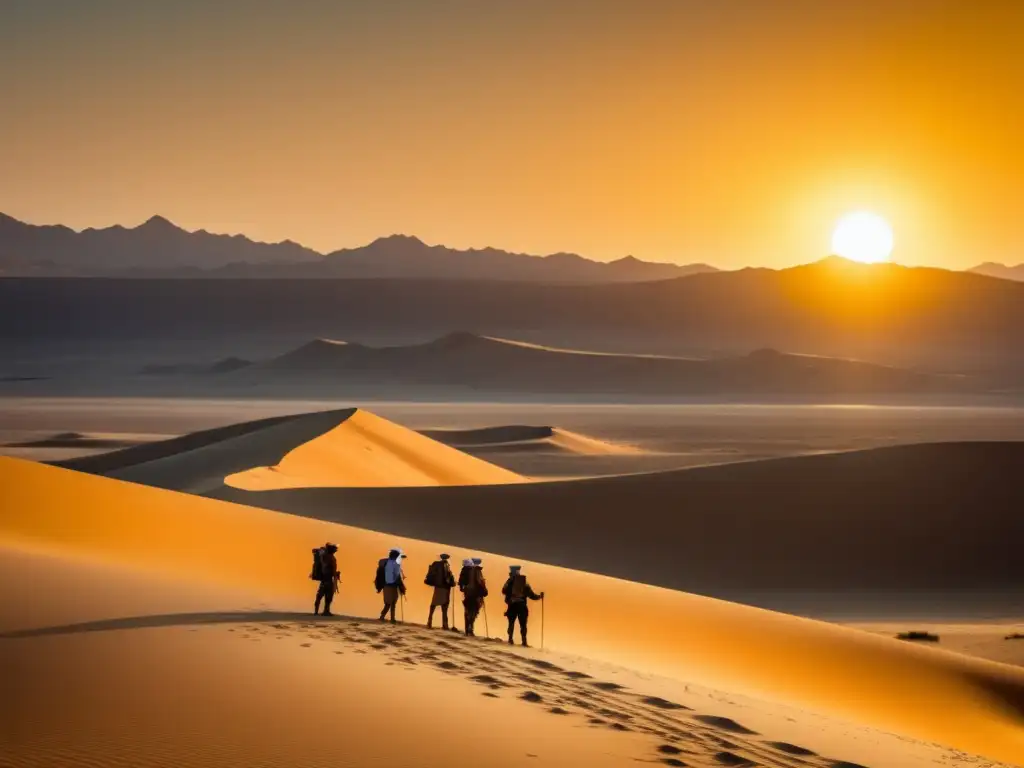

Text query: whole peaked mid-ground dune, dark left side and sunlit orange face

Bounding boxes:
[61,409,522,494]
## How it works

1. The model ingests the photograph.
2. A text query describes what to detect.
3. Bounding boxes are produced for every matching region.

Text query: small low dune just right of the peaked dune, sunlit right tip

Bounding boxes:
[420,425,646,456]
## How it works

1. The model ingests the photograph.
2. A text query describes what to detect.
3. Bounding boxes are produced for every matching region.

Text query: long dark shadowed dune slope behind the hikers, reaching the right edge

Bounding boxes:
[211,442,1024,593]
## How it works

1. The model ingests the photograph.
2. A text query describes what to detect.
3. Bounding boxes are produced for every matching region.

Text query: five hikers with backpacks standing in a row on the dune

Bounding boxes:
[310,543,544,645]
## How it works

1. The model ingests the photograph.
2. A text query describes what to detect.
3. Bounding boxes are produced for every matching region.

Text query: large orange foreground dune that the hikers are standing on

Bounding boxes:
[0,459,1024,766]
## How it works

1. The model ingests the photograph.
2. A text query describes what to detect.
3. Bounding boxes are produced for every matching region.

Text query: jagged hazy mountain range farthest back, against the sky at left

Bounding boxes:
[0,214,714,283]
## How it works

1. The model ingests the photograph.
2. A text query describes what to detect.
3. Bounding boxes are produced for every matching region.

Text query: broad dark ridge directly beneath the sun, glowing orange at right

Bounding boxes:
[6,258,1024,381]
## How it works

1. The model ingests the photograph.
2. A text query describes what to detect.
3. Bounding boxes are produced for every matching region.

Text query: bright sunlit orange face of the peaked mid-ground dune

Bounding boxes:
[224,410,524,490]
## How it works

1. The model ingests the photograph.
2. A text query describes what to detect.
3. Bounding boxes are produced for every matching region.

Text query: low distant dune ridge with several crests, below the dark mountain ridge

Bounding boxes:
[241,333,970,396]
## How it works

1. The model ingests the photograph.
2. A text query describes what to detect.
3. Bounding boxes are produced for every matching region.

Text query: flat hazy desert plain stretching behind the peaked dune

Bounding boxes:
[6,399,1024,477]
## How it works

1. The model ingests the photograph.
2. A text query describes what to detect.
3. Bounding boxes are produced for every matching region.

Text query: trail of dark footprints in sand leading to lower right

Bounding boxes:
[228,618,864,768]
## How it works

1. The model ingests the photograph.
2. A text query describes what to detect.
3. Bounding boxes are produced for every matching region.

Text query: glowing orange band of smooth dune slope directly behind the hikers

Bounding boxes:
[0,459,1024,762]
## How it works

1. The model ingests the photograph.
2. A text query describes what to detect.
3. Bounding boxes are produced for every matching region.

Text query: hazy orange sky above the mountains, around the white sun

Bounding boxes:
[0,0,1024,267]
